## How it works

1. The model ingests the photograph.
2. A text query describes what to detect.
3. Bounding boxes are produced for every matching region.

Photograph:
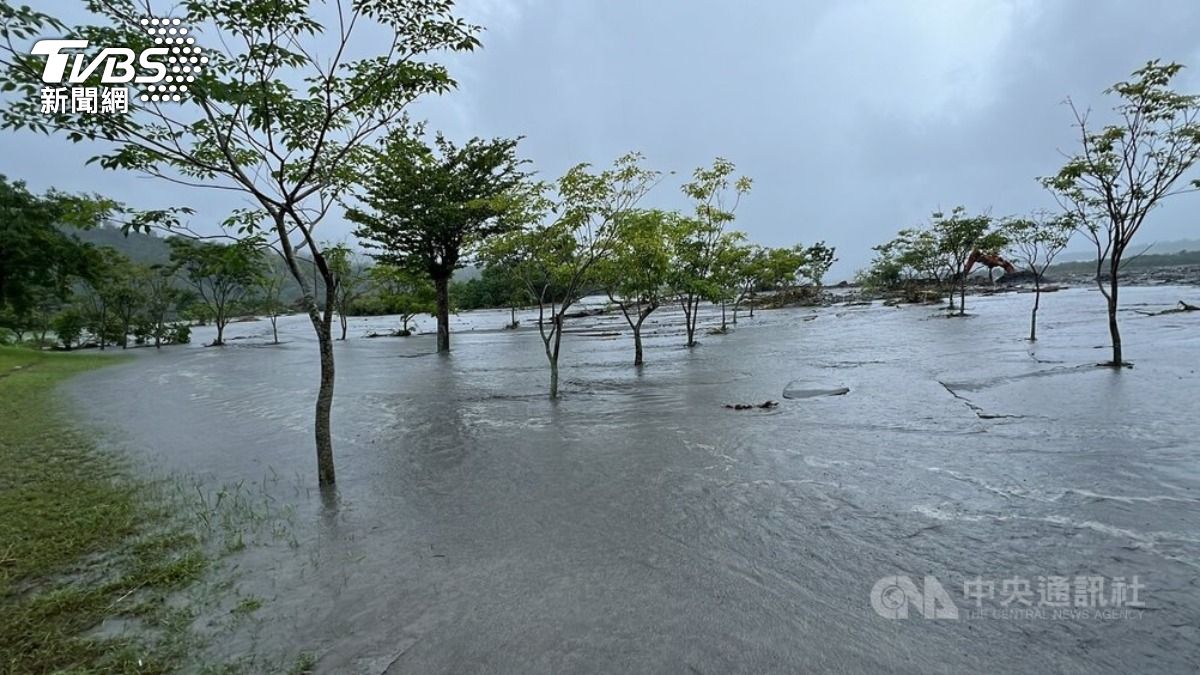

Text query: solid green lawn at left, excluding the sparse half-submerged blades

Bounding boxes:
[0,347,209,674]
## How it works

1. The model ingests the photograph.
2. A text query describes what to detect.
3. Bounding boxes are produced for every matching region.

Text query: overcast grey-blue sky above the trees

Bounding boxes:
[0,0,1200,279]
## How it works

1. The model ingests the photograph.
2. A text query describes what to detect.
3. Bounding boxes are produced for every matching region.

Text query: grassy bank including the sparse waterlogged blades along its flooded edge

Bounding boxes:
[0,347,311,674]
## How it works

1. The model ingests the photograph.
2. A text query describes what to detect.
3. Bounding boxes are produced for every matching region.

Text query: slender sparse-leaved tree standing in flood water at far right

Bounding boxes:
[1042,61,1200,368]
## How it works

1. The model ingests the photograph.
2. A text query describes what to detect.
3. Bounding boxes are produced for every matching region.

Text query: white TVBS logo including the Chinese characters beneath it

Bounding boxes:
[30,17,209,113]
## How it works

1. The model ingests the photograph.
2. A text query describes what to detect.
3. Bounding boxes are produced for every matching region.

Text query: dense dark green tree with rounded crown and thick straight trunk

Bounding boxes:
[346,129,527,352]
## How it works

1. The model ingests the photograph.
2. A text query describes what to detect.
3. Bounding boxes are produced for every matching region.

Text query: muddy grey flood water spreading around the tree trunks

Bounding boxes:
[72,287,1200,674]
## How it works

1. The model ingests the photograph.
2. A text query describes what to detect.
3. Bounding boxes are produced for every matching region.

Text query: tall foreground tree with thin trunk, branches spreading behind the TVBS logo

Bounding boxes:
[0,0,479,485]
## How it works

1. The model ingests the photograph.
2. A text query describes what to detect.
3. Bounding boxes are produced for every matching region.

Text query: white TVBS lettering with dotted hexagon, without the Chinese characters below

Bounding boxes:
[31,18,209,101]
